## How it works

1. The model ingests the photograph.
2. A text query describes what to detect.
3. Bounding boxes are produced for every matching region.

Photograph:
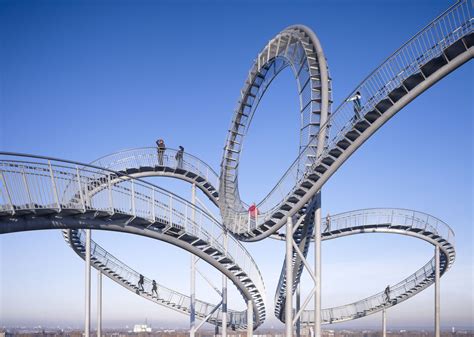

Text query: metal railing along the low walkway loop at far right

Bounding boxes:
[277,208,455,324]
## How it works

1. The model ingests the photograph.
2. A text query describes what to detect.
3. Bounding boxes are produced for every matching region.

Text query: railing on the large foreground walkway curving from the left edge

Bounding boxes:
[0,153,265,316]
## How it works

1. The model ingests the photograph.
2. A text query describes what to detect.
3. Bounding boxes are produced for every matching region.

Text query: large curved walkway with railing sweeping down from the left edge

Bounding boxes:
[0,153,265,328]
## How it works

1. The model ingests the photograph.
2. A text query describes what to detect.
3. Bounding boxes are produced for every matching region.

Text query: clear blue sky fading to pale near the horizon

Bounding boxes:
[0,0,474,328]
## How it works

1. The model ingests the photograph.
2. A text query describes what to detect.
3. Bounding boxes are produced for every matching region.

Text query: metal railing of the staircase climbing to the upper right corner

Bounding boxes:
[224,0,473,233]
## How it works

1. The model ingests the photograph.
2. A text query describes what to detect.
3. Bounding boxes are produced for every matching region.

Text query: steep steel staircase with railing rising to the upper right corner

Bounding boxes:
[220,0,474,241]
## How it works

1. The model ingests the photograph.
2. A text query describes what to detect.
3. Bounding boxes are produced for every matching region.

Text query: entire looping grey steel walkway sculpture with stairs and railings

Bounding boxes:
[0,0,474,329]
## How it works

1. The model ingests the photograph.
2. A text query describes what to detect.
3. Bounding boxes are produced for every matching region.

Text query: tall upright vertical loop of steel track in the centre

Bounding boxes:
[219,25,331,235]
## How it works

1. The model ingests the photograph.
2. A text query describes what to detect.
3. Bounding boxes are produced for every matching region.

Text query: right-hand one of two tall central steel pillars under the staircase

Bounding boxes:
[314,191,321,337]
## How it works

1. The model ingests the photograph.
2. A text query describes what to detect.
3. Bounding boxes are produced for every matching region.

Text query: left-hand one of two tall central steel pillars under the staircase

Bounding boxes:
[285,216,293,337]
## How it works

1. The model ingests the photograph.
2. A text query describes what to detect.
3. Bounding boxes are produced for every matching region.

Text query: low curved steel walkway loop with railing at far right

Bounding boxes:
[275,209,456,324]
